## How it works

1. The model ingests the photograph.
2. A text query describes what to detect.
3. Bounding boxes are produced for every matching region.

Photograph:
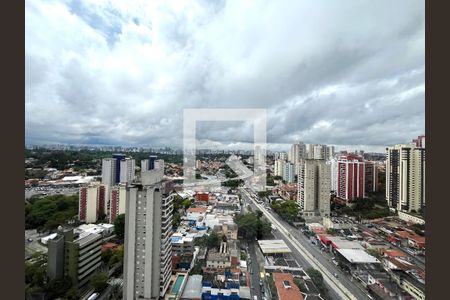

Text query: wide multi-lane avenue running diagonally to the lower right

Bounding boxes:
[241,189,369,299]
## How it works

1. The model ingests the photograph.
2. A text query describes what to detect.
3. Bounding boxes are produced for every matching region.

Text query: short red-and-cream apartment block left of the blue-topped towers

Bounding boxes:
[78,183,107,223]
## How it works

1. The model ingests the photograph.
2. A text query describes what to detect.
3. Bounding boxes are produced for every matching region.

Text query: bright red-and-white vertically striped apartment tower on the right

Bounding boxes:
[336,153,366,201]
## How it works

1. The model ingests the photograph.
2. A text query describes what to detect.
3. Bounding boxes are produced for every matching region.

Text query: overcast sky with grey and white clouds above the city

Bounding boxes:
[25,0,425,151]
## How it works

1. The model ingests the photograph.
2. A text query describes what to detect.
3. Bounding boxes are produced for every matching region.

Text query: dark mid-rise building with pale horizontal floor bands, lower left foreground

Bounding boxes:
[47,227,102,288]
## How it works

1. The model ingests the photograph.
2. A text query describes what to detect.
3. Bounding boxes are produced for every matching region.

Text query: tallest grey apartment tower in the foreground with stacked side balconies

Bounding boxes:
[123,169,173,300]
